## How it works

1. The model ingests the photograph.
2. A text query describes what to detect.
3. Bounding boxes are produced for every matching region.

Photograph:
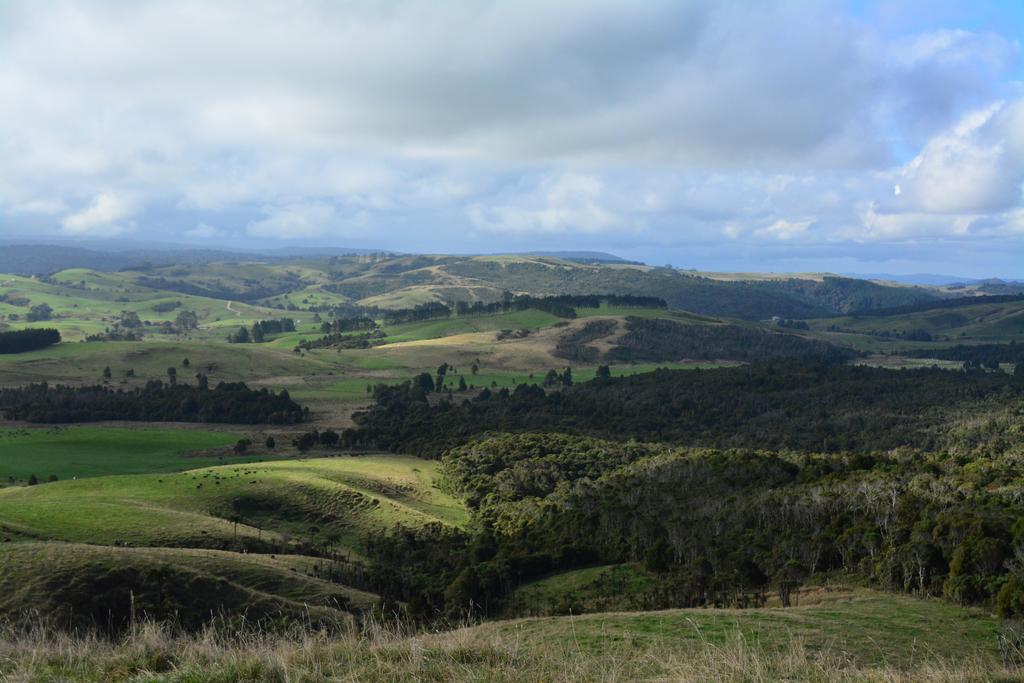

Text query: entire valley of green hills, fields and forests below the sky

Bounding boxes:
[0,249,1024,680]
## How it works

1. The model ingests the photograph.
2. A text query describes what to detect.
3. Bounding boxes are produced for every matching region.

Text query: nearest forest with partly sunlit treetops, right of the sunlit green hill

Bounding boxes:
[354,433,1024,616]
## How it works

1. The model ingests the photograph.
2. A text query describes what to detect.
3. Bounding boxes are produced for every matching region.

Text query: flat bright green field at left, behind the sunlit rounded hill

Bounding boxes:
[0,427,239,481]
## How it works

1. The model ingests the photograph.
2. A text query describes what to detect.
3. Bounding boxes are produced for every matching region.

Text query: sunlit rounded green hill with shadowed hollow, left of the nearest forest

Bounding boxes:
[0,456,467,550]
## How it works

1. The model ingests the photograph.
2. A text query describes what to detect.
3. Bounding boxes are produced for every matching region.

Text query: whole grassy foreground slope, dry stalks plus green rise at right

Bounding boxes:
[0,591,1024,683]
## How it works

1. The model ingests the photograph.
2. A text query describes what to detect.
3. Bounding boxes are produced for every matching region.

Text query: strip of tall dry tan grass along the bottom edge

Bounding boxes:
[0,617,1024,683]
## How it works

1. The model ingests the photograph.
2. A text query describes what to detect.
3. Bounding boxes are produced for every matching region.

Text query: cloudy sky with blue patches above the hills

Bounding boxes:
[0,0,1024,278]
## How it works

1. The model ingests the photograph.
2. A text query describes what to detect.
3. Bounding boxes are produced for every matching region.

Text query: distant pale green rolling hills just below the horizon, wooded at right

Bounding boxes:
[0,253,952,319]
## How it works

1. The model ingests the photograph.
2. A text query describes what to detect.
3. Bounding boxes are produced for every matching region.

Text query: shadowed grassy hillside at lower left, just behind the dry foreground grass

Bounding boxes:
[0,543,376,630]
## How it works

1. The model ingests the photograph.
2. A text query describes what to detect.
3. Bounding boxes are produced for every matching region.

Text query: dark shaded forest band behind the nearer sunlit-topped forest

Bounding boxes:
[343,361,1024,458]
